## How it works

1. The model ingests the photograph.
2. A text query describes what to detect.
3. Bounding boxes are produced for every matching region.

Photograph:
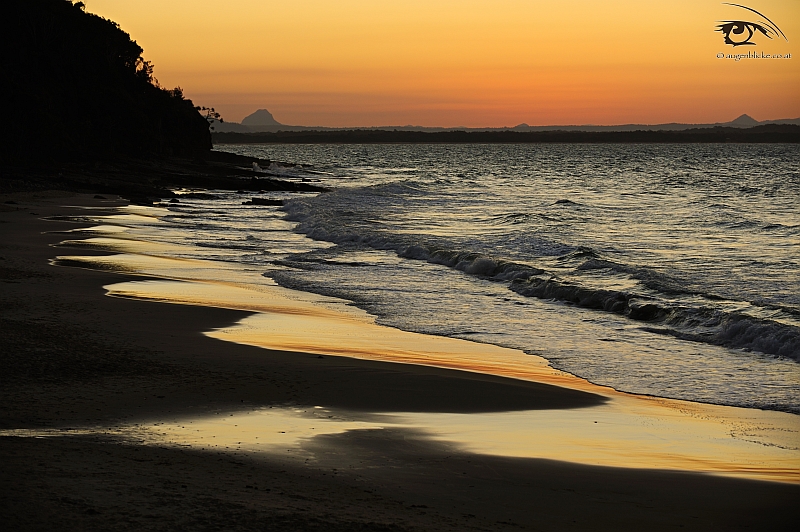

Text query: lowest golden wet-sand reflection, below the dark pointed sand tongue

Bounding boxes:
[117,400,800,484]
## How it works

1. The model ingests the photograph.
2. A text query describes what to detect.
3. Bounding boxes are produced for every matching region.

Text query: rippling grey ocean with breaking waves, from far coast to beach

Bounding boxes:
[125,144,800,413]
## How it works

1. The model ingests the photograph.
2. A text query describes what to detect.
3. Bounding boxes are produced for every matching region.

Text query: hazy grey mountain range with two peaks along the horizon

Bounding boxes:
[211,109,800,133]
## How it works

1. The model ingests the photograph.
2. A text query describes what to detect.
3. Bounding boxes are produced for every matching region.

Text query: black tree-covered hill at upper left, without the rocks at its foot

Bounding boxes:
[0,0,211,161]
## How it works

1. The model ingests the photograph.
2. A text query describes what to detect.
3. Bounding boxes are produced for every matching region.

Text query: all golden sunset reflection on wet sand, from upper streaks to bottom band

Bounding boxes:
[50,230,800,483]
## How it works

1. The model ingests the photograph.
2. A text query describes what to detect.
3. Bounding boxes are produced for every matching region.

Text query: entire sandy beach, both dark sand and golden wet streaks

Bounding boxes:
[0,193,800,530]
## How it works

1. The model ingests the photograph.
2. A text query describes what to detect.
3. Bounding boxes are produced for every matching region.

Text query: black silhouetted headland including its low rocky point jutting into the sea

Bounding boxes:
[0,0,319,201]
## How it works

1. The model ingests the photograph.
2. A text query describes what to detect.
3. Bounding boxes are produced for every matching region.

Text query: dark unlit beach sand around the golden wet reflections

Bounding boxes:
[0,193,800,530]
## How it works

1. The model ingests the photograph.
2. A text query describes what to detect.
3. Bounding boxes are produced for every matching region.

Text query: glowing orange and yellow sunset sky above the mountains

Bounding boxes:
[84,0,800,127]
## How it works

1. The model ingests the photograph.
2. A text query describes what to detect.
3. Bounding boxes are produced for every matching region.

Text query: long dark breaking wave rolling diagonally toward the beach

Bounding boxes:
[283,189,800,361]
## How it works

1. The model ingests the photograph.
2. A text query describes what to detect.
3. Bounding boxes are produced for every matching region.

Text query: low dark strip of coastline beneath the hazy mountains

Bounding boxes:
[211,124,800,145]
